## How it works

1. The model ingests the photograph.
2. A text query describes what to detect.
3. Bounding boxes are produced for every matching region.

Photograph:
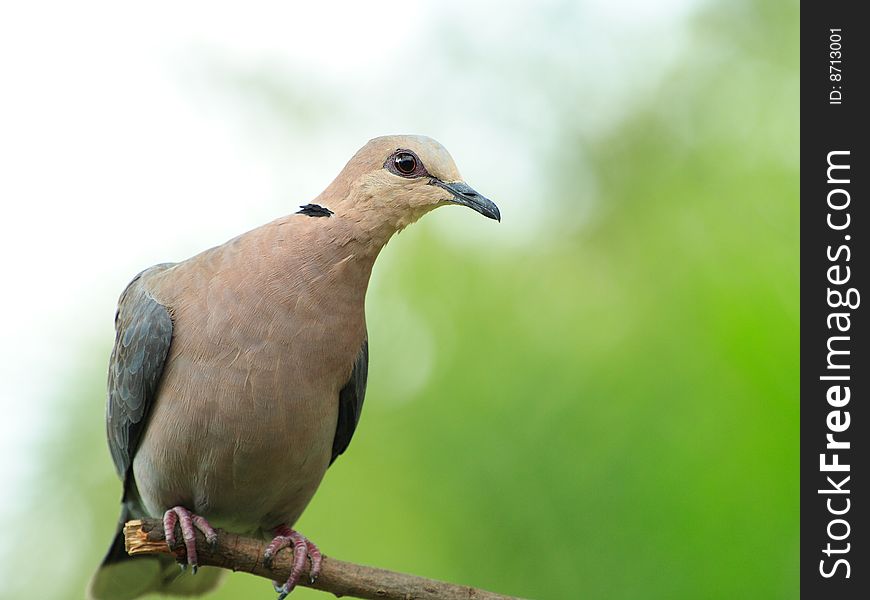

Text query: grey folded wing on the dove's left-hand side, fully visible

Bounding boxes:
[106,264,172,479]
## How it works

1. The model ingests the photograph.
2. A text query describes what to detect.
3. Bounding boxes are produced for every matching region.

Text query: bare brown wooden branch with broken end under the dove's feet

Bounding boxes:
[124,519,512,600]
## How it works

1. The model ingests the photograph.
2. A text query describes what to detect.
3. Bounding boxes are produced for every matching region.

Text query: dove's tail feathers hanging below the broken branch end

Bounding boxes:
[88,507,223,600]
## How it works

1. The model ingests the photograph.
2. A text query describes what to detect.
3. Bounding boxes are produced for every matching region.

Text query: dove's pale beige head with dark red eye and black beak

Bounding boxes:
[327,135,501,236]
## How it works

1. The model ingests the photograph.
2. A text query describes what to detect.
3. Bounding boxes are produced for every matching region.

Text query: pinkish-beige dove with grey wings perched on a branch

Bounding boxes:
[88,135,501,600]
